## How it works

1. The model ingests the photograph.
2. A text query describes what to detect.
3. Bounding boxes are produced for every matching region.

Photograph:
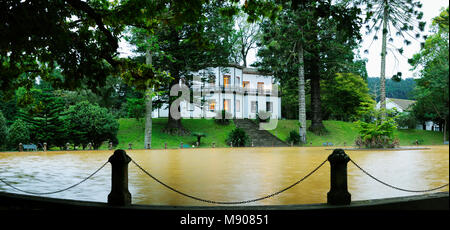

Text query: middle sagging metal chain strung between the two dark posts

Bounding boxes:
[131,159,328,205]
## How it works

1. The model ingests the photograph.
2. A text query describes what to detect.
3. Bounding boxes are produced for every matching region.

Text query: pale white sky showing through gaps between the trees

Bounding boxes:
[119,0,449,78]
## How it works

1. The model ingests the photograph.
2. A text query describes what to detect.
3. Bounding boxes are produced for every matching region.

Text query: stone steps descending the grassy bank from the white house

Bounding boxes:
[234,119,288,147]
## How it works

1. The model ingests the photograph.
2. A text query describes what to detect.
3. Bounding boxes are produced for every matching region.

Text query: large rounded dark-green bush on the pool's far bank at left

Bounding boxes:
[65,101,119,149]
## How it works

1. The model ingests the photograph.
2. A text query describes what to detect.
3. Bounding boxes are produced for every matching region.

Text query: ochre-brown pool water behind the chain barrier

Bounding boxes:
[0,145,449,205]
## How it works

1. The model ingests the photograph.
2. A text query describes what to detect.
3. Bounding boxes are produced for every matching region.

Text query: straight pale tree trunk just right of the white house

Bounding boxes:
[298,42,306,144]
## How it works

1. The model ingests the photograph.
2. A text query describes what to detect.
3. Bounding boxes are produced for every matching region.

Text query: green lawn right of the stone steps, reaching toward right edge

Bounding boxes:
[270,120,444,146]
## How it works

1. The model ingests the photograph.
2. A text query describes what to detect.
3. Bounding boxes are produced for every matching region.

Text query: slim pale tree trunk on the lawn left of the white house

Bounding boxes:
[144,34,153,149]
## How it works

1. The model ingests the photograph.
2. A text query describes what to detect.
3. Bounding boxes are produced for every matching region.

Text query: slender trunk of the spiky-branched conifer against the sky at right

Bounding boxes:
[380,8,388,120]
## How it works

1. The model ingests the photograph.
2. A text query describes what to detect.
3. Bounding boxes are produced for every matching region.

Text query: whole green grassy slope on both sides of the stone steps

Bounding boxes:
[101,118,443,149]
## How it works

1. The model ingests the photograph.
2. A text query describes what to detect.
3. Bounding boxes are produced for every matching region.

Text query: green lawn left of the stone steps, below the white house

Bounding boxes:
[109,118,235,149]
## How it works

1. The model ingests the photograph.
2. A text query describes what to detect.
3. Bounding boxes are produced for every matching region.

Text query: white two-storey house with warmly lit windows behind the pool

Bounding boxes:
[153,65,281,119]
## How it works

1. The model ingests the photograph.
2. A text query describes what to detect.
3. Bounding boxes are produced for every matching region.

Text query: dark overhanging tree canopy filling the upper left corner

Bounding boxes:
[0,0,277,95]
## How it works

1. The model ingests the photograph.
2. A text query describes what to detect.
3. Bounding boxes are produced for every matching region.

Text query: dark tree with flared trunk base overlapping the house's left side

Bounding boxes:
[125,2,237,134]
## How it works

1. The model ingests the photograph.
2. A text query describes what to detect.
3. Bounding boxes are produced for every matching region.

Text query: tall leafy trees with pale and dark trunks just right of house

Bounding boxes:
[256,1,359,140]
